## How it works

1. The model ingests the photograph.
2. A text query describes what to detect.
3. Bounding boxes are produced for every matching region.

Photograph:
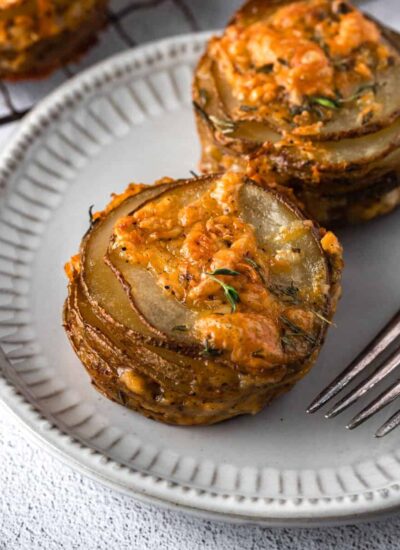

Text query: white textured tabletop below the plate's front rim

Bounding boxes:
[0,409,400,550]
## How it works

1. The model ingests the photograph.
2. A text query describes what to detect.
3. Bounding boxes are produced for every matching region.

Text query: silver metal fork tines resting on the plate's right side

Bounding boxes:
[307,311,400,437]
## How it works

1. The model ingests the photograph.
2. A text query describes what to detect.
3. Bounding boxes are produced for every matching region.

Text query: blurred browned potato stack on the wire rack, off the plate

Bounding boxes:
[0,0,107,79]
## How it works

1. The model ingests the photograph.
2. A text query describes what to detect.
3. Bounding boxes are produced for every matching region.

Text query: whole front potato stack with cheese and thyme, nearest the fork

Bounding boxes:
[64,172,342,425]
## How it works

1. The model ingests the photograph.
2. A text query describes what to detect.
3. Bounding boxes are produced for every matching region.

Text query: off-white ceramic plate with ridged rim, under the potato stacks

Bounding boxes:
[0,31,400,525]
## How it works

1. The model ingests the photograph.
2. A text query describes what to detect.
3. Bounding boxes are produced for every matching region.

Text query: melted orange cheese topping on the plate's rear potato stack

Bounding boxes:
[209,0,392,128]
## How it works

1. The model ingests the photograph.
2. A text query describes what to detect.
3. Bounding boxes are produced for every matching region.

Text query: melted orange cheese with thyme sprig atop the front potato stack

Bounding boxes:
[112,173,328,376]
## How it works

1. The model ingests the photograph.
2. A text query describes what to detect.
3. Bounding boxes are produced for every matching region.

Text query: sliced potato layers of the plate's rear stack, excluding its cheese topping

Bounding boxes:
[193,0,400,224]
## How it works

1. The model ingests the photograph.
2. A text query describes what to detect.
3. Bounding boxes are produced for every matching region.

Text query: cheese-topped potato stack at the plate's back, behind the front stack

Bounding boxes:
[193,0,400,224]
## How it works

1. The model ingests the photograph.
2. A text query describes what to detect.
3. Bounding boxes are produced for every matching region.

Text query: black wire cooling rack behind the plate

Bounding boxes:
[0,0,200,127]
